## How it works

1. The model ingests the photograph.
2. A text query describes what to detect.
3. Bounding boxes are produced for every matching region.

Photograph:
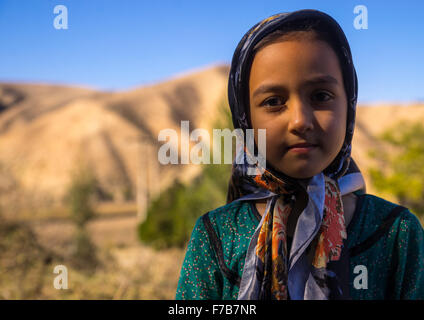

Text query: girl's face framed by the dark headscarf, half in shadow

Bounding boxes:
[249,39,347,179]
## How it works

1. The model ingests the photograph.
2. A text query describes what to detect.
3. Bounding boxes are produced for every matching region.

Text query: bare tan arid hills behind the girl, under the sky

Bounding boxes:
[0,65,424,216]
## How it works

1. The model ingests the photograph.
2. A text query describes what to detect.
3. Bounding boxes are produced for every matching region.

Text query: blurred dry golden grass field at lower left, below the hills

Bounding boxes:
[0,212,184,299]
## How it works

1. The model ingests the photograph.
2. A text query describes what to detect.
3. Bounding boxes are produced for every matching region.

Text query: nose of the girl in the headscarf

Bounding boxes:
[288,99,313,133]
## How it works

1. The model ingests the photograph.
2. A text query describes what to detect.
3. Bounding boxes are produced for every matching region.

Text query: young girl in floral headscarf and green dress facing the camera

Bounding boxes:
[176,10,424,300]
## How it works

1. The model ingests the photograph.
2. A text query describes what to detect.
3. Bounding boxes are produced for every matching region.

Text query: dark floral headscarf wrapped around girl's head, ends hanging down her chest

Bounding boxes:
[227,10,365,299]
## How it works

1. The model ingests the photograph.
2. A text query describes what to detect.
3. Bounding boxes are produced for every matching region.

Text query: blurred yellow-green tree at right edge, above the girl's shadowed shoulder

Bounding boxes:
[369,122,424,216]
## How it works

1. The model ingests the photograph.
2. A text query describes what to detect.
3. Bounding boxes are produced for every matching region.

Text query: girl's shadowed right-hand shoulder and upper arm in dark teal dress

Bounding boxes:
[347,194,424,300]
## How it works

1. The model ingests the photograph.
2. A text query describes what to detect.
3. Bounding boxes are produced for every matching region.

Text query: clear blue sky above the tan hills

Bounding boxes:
[0,0,424,102]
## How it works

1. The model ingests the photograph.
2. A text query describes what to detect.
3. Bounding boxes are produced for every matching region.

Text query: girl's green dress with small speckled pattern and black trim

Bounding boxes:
[176,193,424,300]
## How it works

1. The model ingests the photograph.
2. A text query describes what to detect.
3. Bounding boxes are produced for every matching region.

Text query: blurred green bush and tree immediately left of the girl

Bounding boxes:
[138,97,235,249]
